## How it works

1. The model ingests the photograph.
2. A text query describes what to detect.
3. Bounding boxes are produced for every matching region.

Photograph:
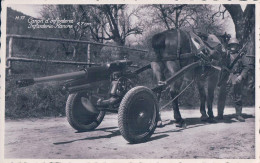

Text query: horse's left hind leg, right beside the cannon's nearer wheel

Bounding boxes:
[151,62,165,127]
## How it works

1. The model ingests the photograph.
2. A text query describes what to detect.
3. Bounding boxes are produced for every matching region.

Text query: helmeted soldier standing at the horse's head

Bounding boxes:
[217,38,249,122]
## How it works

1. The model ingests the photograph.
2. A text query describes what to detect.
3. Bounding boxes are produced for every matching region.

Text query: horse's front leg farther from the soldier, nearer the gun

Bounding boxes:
[196,78,208,121]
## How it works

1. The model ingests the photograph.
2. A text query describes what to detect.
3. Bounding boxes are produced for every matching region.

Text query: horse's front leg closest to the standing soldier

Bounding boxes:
[207,72,218,123]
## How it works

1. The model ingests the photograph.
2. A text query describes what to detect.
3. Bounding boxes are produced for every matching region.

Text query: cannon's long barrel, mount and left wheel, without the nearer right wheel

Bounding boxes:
[16,60,150,131]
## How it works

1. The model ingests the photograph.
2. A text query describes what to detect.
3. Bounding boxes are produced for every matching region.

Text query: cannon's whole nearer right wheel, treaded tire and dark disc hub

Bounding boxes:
[118,86,159,143]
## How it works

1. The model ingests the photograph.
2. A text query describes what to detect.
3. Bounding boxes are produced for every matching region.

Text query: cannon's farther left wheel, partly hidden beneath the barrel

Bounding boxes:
[66,92,106,132]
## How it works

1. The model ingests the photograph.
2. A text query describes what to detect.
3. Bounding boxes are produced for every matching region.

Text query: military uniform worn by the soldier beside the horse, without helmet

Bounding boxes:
[218,38,249,121]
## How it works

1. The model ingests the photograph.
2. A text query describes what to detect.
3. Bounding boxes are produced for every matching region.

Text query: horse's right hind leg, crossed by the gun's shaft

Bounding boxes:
[166,61,186,127]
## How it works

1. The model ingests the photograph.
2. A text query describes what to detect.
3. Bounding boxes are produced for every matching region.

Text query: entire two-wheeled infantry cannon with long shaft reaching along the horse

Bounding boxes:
[16,50,214,143]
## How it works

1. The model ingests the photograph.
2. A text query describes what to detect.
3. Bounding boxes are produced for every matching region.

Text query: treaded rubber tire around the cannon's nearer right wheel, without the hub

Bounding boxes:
[118,86,159,143]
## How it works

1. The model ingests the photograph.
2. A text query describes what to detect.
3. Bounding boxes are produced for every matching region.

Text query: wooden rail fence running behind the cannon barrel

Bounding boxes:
[6,35,147,75]
